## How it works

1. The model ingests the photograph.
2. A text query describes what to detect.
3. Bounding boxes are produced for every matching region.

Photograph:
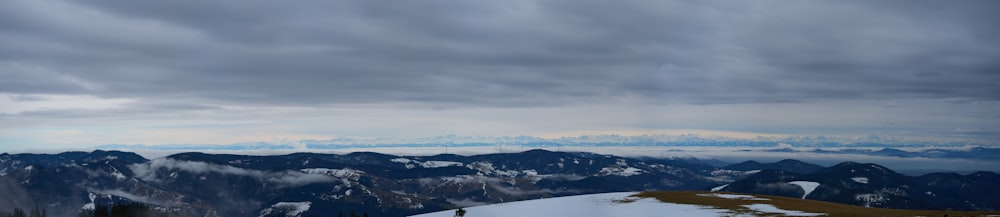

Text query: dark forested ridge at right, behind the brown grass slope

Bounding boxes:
[719,162,1000,211]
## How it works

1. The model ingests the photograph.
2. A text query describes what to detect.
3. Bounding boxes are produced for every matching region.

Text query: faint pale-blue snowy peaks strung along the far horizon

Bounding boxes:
[97,134,1000,151]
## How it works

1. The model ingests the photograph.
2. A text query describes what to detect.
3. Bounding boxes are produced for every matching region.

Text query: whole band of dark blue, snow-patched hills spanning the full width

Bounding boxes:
[0,150,1000,216]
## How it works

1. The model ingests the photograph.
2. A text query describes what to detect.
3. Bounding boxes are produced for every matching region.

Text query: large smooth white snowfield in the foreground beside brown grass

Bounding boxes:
[414,192,732,217]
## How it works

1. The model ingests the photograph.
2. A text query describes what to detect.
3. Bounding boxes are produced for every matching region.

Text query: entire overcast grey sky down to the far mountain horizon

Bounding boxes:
[0,0,1000,151]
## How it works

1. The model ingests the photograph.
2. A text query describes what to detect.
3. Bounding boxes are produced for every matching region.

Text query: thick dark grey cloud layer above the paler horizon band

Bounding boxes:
[0,1,1000,106]
